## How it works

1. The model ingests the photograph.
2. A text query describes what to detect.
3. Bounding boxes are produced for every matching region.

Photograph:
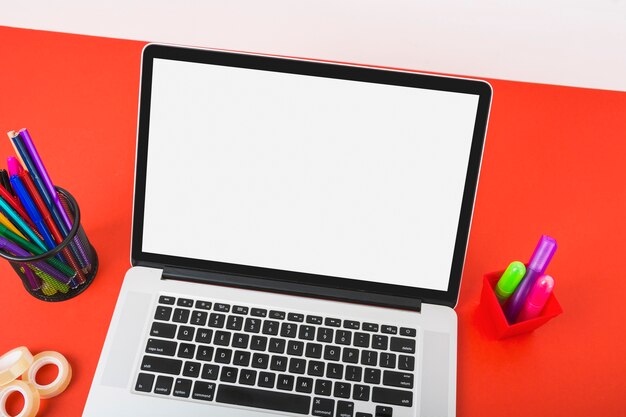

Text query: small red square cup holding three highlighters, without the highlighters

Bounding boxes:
[479,271,563,339]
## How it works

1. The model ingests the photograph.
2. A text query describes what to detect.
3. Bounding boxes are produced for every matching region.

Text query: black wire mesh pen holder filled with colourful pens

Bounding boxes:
[0,187,98,301]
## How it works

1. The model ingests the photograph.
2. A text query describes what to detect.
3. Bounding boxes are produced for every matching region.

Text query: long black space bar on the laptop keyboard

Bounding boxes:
[215,384,311,414]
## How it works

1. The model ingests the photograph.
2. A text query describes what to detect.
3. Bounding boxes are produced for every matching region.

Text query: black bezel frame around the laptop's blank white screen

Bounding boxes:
[131,44,492,307]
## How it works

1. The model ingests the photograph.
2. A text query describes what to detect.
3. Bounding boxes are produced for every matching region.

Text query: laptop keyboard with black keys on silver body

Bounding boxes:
[134,295,417,417]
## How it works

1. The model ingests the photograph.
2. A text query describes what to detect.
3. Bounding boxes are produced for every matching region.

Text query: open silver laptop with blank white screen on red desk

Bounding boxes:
[83,44,491,417]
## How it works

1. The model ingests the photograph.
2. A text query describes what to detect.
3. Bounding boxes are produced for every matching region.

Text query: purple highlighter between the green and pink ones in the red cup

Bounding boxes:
[504,235,556,324]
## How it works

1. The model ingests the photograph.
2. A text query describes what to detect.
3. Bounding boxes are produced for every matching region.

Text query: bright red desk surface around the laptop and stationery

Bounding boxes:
[0,27,626,417]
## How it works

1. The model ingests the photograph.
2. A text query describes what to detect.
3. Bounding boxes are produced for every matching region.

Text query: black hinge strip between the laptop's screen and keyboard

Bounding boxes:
[162,267,422,312]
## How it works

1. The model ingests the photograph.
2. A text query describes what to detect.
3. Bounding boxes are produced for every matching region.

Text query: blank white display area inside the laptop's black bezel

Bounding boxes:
[142,59,479,291]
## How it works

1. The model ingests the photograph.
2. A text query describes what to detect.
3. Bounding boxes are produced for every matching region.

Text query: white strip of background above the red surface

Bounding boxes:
[0,0,626,91]
